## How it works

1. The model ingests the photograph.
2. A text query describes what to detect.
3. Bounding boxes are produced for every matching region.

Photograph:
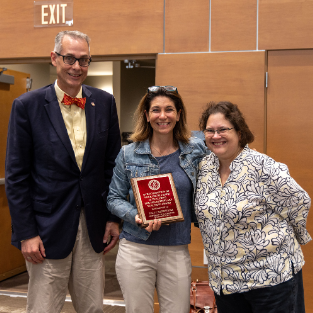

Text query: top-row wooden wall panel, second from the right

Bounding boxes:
[211,0,257,51]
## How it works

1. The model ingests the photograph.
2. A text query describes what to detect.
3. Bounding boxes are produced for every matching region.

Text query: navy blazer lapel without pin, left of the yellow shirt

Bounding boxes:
[45,85,78,167]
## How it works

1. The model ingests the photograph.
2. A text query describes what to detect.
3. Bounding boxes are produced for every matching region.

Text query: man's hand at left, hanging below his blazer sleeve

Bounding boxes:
[21,236,46,264]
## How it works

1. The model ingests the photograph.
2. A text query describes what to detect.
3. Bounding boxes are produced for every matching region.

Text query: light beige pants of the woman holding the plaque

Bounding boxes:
[116,239,191,313]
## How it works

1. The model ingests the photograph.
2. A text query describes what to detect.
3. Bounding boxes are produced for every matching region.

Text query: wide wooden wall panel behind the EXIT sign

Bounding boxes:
[0,0,164,58]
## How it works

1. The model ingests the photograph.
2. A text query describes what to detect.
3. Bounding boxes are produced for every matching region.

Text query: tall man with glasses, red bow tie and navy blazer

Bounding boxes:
[5,31,120,313]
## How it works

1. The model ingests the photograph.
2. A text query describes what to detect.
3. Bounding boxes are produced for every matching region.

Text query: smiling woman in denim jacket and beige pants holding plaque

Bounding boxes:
[107,86,207,313]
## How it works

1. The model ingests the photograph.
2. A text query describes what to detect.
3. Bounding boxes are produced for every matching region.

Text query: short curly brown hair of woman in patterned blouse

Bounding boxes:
[199,101,254,148]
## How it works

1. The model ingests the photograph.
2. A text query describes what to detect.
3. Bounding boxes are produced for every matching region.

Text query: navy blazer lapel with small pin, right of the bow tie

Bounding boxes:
[82,85,96,171]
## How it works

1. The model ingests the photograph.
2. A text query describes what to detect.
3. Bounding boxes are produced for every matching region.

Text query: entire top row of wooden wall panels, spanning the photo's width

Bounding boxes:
[0,0,313,59]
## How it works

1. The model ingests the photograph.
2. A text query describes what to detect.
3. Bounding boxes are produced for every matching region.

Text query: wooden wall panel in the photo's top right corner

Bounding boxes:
[259,0,313,50]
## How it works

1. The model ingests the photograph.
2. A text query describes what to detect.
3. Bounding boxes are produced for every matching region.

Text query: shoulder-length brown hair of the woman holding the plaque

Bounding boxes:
[129,87,190,143]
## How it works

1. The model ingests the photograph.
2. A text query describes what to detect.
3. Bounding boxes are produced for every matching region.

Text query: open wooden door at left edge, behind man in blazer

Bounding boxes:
[0,70,30,281]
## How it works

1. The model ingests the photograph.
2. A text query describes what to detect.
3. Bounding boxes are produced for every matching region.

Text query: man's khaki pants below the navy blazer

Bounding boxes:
[26,210,104,313]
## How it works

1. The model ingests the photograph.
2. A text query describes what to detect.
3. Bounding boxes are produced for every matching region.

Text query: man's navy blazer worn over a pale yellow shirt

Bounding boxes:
[5,85,121,259]
